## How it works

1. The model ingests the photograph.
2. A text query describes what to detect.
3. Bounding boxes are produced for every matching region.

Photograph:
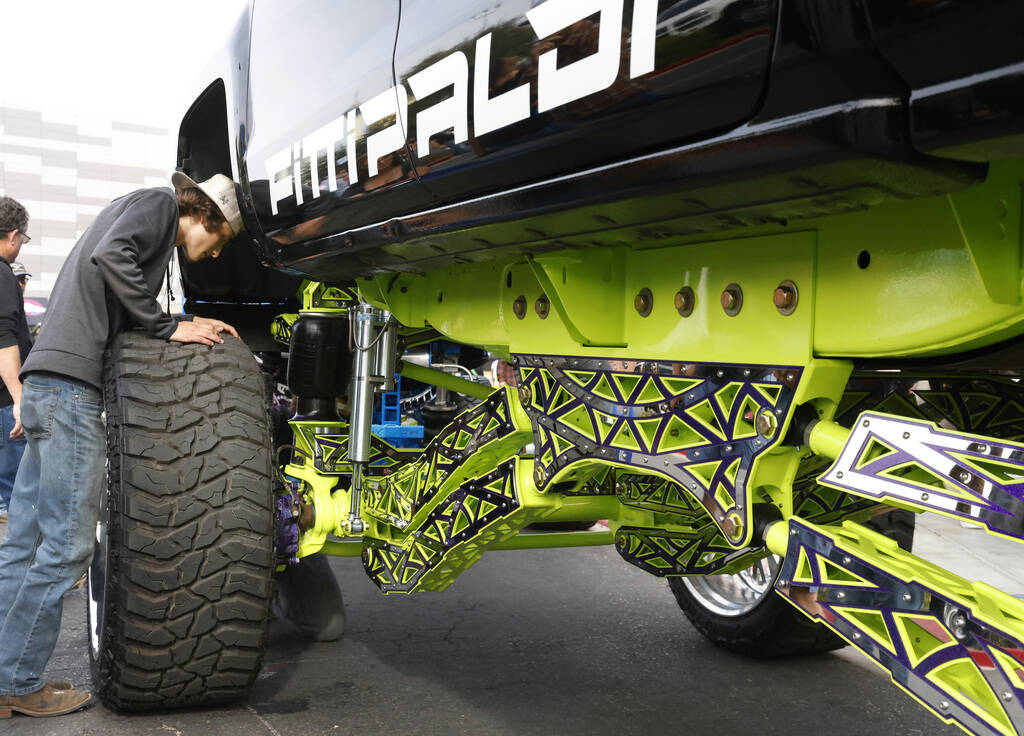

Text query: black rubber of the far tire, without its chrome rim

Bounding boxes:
[669,510,914,659]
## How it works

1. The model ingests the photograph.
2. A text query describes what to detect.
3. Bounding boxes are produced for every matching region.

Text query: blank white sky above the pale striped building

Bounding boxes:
[0,0,245,135]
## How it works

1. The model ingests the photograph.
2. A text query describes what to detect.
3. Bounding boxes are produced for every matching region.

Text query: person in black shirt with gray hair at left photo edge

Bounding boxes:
[0,197,32,520]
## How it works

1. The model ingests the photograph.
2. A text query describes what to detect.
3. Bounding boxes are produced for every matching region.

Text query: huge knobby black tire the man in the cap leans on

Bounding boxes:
[88,333,273,710]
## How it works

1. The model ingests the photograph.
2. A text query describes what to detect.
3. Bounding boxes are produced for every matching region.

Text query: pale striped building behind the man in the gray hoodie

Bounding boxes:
[0,107,174,300]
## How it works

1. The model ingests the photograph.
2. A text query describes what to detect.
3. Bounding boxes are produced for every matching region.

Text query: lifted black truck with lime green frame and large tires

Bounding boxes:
[90,0,1024,734]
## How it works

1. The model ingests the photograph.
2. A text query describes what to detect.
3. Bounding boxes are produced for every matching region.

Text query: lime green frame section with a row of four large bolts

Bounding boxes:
[360,232,816,365]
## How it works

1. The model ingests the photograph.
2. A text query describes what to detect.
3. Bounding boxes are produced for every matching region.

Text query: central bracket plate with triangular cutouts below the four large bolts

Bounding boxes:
[513,355,802,540]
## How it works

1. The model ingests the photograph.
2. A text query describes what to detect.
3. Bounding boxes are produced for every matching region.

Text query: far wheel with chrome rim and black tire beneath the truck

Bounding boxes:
[669,510,914,659]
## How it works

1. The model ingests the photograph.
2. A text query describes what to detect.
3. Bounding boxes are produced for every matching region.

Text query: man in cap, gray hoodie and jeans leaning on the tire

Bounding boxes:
[0,174,243,718]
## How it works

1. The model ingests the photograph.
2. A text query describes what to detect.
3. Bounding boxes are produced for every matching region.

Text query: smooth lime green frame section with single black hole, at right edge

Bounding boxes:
[812,162,1024,356]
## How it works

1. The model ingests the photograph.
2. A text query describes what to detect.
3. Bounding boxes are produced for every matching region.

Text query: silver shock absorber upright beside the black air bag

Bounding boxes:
[348,303,397,534]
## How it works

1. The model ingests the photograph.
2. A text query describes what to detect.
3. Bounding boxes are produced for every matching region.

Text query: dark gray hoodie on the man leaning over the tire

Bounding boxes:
[22,188,178,389]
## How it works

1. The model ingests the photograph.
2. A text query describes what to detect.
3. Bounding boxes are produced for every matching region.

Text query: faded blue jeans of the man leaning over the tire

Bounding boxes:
[0,374,106,695]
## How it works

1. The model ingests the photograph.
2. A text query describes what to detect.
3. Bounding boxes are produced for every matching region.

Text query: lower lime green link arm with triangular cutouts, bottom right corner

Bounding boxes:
[768,518,1024,735]
